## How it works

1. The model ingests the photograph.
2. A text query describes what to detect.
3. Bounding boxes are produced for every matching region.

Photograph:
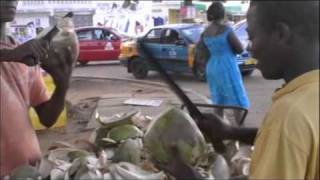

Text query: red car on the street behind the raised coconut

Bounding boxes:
[76,27,122,65]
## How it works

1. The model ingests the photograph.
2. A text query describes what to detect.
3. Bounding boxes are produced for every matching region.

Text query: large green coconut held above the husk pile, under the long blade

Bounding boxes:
[144,108,206,165]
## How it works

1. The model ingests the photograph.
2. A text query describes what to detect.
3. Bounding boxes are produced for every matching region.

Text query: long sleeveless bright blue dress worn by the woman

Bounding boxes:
[203,28,250,109]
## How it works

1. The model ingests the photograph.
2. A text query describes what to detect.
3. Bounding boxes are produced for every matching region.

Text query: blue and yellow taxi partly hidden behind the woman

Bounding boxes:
[119,24,255,81]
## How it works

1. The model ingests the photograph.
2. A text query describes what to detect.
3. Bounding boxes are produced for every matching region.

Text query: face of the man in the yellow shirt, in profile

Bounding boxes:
[247,7,286,79]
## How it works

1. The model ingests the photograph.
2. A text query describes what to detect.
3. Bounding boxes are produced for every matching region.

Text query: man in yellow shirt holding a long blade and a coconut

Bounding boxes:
[154,1,320,179]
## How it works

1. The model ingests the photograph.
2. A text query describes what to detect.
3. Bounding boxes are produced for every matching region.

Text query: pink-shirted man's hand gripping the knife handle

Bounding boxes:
[8,39,49,66]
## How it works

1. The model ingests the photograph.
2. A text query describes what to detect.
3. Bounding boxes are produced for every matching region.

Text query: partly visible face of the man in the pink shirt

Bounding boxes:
[0,0,18,23]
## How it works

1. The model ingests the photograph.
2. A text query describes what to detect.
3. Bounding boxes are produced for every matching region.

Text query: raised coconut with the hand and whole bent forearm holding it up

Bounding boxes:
[36,13,79,127]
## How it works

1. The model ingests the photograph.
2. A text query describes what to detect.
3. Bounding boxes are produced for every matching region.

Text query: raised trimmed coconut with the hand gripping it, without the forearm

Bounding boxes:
[37,12,79,88]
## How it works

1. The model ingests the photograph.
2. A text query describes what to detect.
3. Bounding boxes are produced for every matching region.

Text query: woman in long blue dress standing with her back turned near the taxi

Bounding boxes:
[202,2,249,120]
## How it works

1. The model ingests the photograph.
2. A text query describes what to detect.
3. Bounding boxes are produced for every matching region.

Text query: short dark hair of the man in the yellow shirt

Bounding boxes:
[250,0,319,40]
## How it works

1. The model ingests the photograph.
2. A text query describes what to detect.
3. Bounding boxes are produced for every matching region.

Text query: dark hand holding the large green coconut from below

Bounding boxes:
[154,145,202,179]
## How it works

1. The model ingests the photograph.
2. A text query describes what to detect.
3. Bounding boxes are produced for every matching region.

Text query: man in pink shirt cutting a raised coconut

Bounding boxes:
[0,0,72,179]
